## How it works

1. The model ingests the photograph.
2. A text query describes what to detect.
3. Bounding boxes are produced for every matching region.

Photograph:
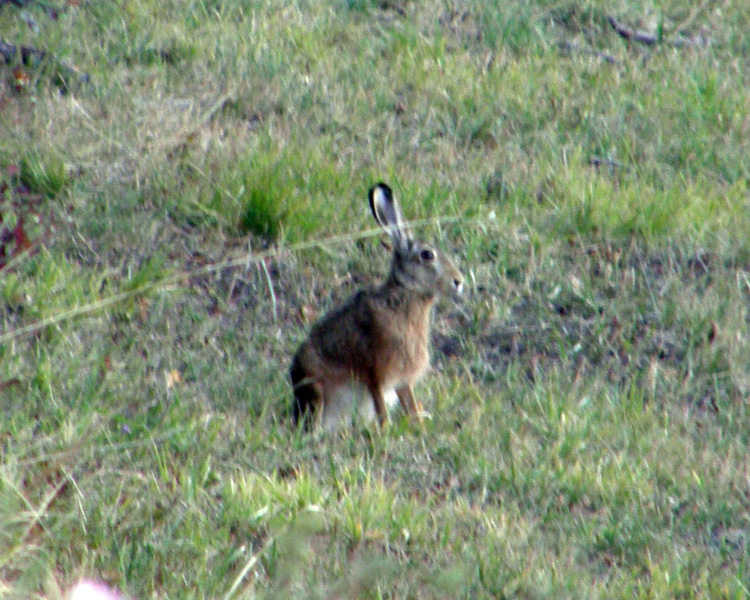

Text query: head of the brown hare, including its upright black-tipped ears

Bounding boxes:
[369,183,464,297]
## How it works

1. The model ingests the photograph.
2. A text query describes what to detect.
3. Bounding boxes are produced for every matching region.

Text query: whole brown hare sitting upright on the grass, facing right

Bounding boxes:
[289,183,463,431]
